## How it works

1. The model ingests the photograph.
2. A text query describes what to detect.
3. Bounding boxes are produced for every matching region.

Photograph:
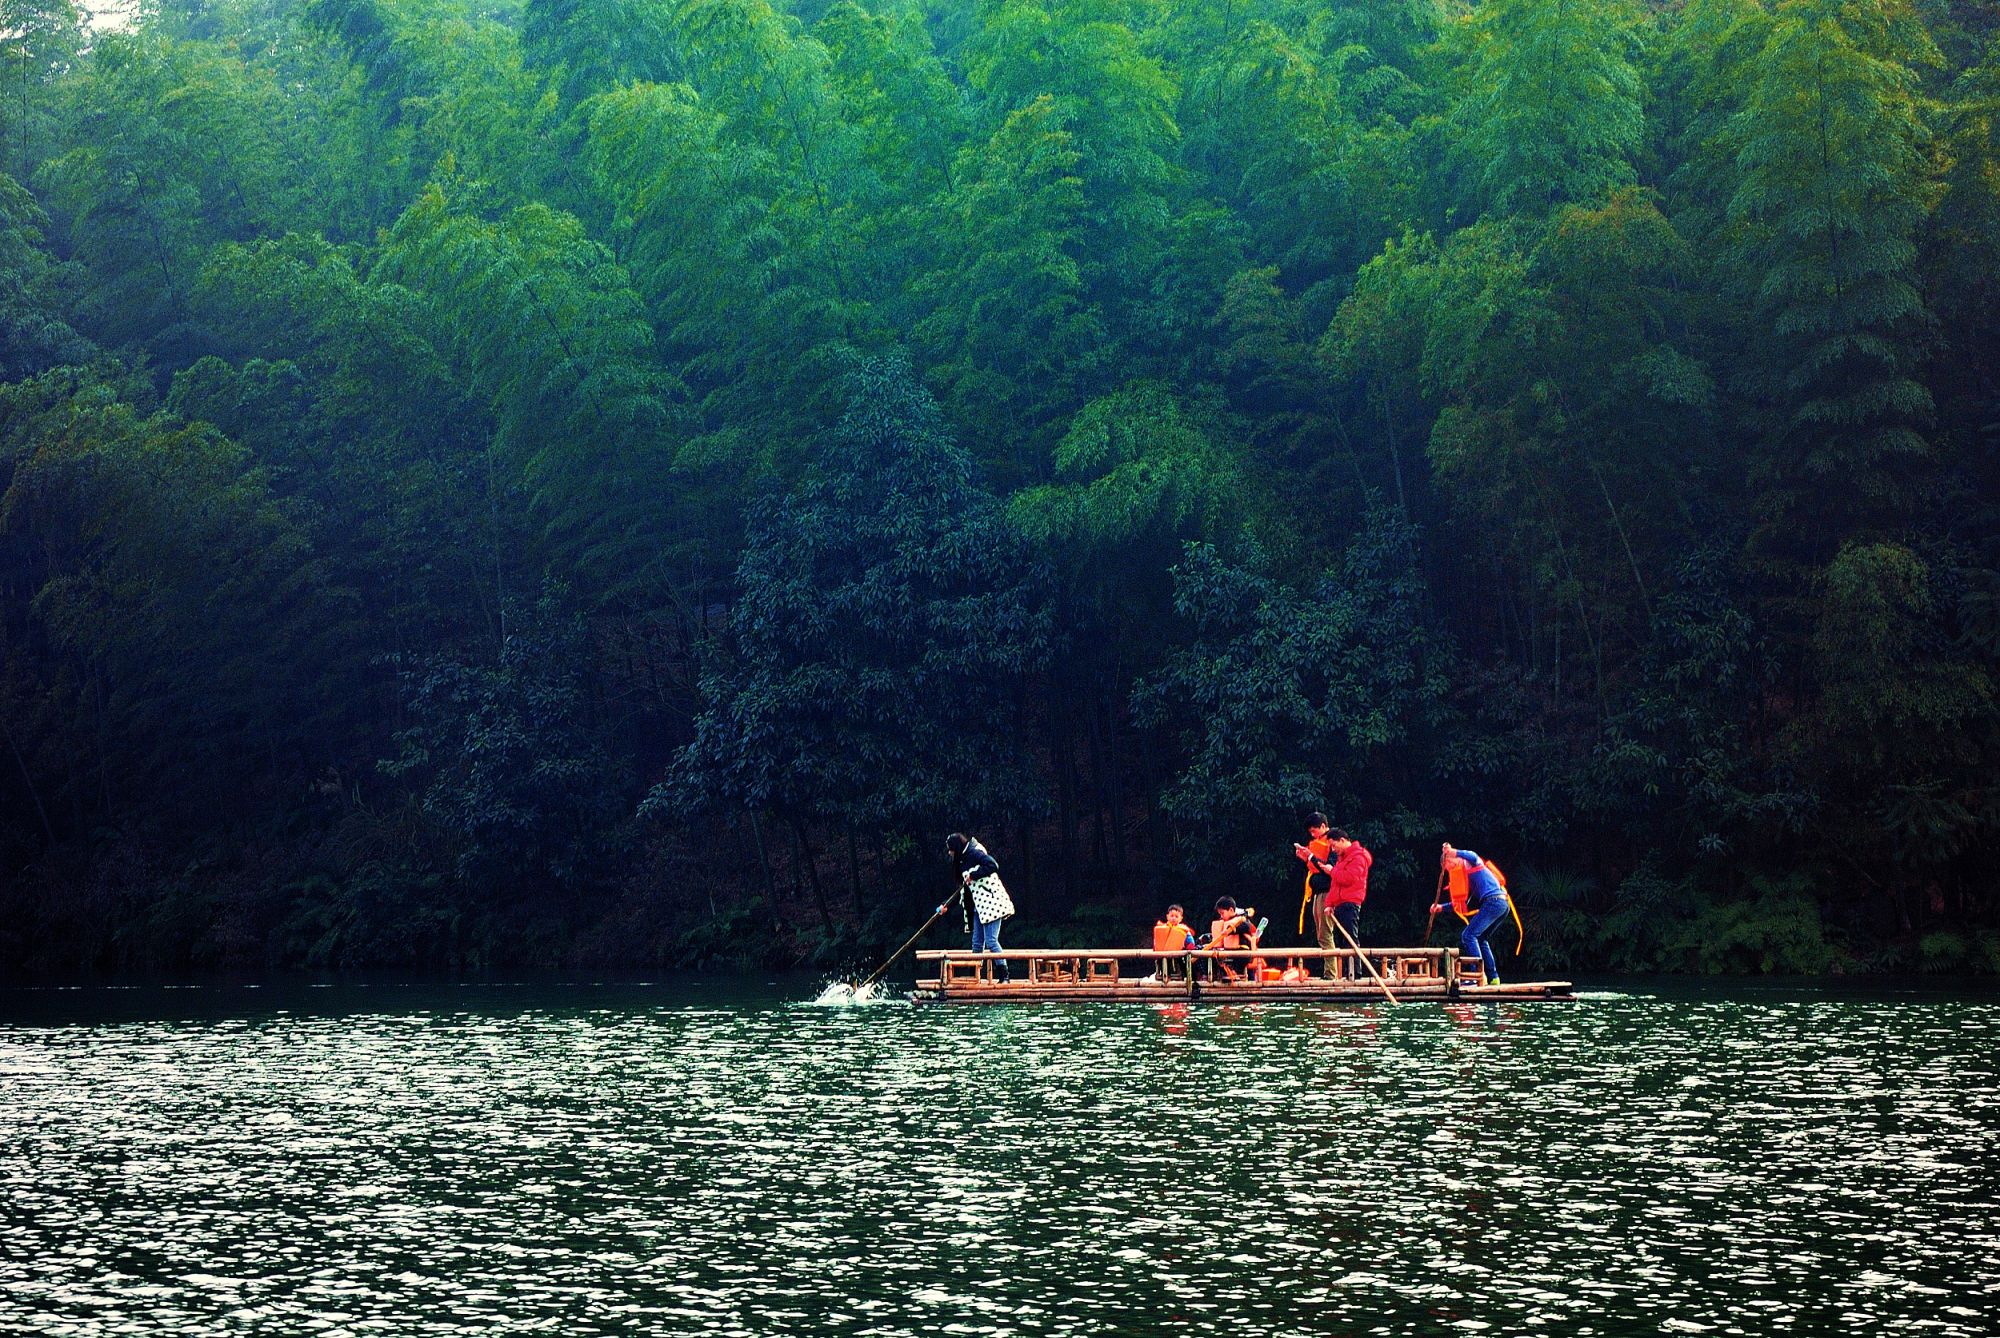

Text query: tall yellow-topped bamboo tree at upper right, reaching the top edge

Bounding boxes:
[1728,0,1936,560]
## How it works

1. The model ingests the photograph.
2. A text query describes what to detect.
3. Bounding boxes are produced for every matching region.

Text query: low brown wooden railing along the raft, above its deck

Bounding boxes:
[916,948,1480,988]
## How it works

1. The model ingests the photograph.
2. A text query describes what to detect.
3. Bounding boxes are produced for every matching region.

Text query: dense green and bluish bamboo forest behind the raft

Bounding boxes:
[0,0,2000,970]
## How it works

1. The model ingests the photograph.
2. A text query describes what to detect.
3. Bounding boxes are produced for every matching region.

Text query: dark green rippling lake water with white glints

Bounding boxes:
[0,982,2000,1338]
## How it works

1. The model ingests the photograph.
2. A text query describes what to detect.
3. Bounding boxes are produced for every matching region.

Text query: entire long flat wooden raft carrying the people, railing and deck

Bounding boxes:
[912,948,1576,1004]
